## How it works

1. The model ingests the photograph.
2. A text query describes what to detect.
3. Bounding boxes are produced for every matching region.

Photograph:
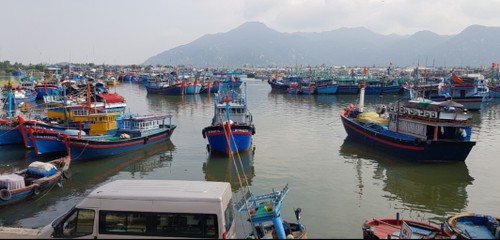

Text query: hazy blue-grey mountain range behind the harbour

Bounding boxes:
[143,22,500,67]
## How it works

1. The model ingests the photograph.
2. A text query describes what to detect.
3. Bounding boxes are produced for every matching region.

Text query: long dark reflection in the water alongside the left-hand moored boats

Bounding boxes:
[0,140,175,227]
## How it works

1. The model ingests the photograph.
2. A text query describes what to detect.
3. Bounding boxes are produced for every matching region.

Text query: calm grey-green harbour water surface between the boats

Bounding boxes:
[0,79,500,238]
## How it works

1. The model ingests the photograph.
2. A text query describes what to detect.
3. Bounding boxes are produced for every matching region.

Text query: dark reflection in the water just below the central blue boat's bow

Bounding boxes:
[203,151,255,192]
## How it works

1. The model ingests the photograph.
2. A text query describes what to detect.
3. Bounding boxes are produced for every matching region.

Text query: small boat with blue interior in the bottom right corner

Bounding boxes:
[445,213,500,239]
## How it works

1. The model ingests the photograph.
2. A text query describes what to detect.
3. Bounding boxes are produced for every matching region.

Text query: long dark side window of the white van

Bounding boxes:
[99,210,219,238]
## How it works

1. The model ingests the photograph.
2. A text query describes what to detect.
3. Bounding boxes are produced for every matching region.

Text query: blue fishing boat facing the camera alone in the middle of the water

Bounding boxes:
[202,84,255,155]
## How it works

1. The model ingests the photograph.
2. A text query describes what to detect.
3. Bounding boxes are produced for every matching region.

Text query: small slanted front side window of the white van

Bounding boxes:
[60,209,95,238]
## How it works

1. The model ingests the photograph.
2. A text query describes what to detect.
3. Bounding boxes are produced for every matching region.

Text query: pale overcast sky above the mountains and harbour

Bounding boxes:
[0,0,500,65]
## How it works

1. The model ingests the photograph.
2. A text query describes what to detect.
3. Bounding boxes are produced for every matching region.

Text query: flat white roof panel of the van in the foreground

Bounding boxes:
[87,180,231,202]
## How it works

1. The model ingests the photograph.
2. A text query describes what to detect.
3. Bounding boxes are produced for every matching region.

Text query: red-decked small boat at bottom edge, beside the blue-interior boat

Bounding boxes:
[362,214,451,239]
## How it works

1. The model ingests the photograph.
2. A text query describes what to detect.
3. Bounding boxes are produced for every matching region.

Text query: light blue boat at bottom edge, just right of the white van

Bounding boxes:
[236,184,307,239]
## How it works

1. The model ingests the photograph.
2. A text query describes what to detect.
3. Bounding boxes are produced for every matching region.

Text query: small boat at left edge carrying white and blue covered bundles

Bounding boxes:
[0,155,71,207]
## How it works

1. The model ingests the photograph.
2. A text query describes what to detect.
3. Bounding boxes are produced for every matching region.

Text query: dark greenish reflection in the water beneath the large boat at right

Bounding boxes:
[339,138,474,220]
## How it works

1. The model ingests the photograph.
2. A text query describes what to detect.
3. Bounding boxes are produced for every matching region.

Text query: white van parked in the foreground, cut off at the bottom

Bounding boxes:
[37,180,236,238]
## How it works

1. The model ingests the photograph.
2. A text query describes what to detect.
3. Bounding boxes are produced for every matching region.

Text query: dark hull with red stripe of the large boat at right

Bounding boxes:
[341,115,476,162]
